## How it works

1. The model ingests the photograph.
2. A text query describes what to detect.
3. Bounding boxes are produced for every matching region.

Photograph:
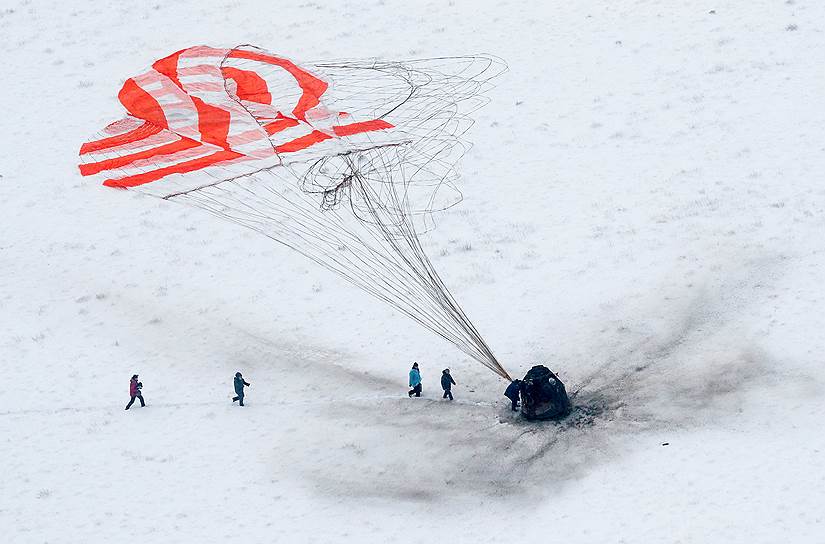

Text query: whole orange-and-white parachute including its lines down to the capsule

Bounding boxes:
[80,46,509,379]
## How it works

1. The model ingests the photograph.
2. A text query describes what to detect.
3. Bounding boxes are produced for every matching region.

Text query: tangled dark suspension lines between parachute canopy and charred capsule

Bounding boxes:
[158,53,511,380]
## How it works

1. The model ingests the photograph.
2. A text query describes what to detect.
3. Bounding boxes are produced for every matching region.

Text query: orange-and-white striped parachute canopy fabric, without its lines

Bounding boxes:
[80,46,393,191]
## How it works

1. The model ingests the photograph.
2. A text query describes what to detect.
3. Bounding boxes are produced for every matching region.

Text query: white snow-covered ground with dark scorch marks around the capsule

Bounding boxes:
[0,0,825,544]
